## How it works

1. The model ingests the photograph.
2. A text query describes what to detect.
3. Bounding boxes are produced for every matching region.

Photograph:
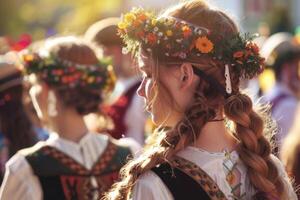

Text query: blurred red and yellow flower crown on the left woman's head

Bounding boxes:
[23,53,116,92]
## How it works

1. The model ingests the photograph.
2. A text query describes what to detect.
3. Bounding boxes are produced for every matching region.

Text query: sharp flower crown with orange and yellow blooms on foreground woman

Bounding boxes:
[118,8,264,79]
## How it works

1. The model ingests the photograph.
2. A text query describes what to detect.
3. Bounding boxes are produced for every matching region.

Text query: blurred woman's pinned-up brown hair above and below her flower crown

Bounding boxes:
[35,37,102,115]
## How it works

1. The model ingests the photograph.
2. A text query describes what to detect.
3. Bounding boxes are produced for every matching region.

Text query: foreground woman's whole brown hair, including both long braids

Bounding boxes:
[105,0,285,199]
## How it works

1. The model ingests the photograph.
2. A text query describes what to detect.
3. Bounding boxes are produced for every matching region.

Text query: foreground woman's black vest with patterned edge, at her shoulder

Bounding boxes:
[152,156,227,200]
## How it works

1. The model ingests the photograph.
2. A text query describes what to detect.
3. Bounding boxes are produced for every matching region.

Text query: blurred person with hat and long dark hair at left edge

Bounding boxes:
[0,56,37,182]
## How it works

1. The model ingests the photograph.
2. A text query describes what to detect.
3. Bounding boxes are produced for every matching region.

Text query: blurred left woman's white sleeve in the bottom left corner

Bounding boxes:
[0,153,42,200]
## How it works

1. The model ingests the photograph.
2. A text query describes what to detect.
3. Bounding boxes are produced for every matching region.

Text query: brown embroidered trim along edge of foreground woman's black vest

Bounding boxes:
[172,156,227,200]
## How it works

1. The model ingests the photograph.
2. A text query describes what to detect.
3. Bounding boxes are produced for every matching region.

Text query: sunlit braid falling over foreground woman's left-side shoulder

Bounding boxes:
[103,82,215,200]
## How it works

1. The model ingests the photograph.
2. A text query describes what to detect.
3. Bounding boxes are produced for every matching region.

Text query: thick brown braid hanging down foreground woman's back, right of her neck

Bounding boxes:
[224,93,283,199]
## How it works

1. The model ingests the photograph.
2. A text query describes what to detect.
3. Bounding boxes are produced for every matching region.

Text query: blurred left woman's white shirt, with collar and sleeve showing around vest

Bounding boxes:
[0,133,139,200]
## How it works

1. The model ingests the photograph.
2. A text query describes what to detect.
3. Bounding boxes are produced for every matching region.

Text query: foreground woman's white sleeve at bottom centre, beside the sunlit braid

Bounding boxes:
[132,171,173,200]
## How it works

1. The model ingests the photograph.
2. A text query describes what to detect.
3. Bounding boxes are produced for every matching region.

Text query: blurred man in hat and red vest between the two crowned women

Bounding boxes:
[85,18,146,144]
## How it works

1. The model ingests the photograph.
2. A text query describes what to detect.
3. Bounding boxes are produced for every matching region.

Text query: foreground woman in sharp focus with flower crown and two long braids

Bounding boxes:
[105,0,296,200]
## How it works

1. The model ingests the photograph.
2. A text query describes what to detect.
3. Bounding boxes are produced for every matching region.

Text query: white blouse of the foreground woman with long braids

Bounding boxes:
[132,146,297,200]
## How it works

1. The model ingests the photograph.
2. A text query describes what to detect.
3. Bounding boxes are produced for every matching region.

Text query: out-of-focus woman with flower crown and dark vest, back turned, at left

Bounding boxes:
[0,37,141,200]
